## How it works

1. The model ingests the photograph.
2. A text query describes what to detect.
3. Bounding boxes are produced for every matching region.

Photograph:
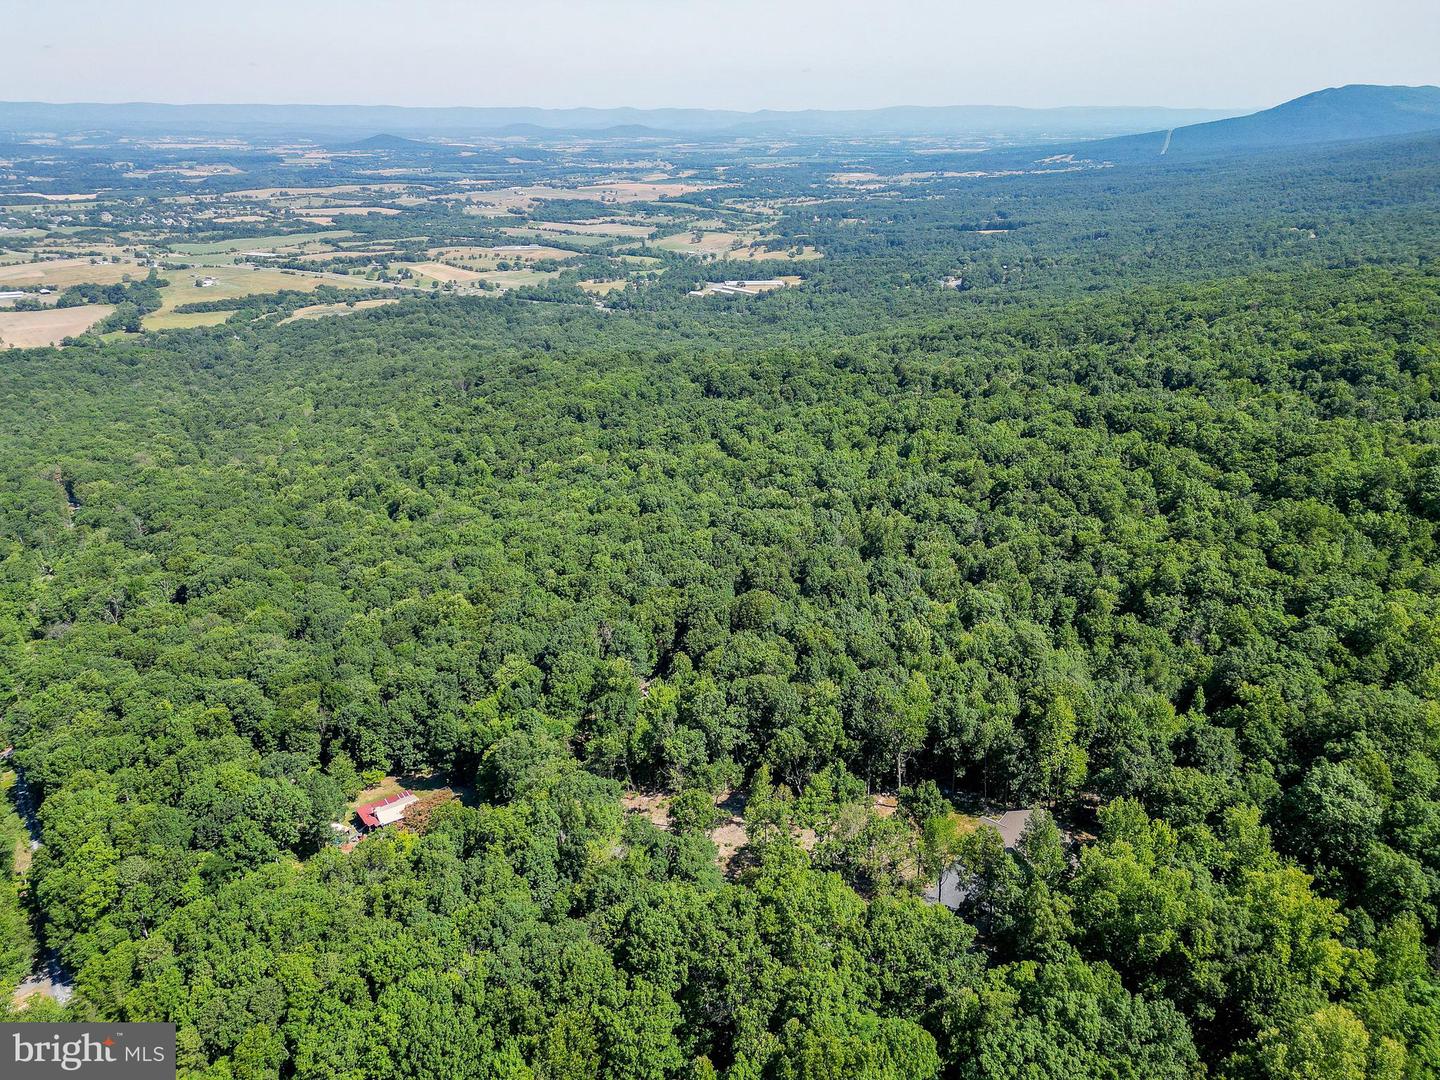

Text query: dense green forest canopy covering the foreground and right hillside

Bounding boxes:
[0,124,1440,1080]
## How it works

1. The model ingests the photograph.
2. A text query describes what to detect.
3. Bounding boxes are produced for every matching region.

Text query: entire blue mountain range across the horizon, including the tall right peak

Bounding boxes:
[0,85,1440,160]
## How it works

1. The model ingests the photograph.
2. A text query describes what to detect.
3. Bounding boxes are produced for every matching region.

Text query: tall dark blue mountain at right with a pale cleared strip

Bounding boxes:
[1086,84,1440,158]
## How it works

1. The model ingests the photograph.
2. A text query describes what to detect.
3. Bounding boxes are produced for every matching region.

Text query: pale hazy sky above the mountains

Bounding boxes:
[0,0,1440,109]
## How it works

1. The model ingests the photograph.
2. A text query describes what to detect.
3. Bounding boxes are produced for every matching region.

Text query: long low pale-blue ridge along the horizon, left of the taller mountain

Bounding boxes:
[0,101,1237,141]
